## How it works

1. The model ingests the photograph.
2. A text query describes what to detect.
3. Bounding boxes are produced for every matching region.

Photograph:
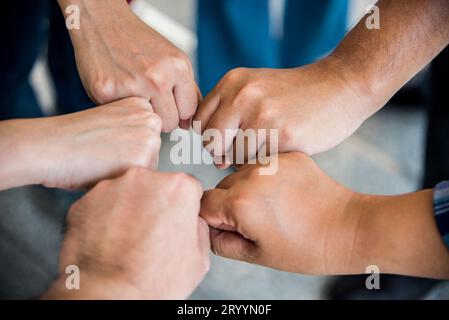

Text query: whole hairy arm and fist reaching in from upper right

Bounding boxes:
[194,0,449,168]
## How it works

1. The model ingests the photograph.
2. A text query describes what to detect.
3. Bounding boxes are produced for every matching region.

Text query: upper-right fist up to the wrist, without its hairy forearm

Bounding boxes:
[194,57,369,167]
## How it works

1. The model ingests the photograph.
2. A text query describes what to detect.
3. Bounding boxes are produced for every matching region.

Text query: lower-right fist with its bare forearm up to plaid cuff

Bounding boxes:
[200,153,449,279]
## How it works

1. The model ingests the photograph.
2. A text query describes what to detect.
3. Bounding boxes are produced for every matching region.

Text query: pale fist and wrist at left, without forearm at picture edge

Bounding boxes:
[35,98,162,189]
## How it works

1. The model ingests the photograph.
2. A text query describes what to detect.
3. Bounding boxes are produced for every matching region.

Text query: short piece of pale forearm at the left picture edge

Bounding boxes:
[0,120,42,190]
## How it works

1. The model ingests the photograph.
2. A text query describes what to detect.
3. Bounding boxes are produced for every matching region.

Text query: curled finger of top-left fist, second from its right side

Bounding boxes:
[151,92,179,133]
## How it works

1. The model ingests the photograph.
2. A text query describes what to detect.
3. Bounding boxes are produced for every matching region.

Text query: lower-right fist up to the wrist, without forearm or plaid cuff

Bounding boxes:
[201,153,355,274]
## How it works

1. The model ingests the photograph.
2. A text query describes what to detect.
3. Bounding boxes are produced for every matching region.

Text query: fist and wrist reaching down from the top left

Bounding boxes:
[58,0,200,132]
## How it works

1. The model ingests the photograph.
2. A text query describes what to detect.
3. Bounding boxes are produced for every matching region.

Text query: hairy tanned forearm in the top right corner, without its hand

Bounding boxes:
[330,0,449,119]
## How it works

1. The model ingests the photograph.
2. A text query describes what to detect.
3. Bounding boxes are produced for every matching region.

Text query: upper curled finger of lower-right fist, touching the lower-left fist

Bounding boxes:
[200,189,235,230]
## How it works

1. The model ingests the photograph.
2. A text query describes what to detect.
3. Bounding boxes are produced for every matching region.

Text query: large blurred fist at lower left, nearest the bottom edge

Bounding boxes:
[45,169,210,299]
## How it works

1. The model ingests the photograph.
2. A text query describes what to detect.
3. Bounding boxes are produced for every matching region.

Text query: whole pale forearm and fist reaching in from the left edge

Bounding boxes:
[0,98,162,190]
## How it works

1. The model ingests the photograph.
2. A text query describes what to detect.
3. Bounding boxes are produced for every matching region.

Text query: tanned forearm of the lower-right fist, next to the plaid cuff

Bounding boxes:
[350,190,449,279]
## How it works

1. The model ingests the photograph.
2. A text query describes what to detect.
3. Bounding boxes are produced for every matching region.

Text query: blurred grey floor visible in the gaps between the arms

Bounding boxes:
[0,0,444,299]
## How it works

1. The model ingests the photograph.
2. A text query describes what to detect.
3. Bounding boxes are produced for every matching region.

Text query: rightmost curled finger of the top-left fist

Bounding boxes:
[173,80,198,120]
